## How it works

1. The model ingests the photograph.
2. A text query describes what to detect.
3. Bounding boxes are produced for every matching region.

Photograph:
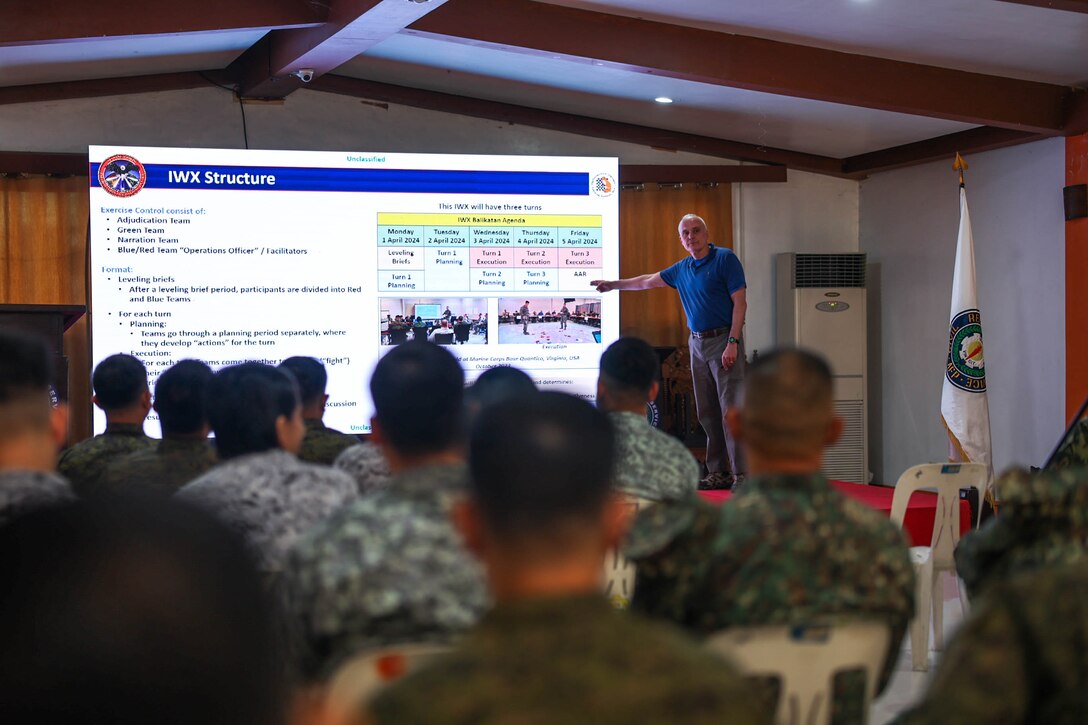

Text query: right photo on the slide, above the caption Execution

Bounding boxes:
[498,297,602,345]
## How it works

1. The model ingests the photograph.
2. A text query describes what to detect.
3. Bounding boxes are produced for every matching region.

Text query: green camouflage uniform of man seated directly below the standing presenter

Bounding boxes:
[626,475,914,723]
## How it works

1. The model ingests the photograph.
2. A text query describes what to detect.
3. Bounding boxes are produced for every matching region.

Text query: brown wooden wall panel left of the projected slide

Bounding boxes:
[0,176,90,441]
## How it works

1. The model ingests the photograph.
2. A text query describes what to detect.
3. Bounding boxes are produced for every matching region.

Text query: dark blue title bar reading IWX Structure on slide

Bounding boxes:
[90,163,590,196]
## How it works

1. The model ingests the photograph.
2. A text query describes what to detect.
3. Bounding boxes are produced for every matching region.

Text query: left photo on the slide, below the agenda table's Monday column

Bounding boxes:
[380,297,487,345]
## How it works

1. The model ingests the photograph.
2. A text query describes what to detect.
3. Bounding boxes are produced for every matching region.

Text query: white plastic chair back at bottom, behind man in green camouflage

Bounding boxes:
[706,620,891,725]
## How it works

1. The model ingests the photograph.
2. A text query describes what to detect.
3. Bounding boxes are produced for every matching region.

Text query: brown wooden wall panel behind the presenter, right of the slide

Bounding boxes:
[618,184,733,346]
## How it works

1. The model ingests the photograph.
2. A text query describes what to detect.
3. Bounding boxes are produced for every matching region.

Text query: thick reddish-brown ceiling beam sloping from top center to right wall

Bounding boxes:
[405,0,1072,135]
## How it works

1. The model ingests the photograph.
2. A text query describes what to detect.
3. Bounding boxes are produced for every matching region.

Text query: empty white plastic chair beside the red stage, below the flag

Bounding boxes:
[891,464,989,672]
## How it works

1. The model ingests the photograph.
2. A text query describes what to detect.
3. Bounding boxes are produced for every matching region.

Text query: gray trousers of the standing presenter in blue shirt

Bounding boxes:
[691,334,747,474]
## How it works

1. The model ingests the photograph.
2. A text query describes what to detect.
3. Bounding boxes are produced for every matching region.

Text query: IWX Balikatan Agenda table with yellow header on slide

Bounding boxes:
[378,212,603,294]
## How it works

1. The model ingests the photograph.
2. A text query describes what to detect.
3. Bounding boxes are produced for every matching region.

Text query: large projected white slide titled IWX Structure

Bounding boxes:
[89,146,619,437]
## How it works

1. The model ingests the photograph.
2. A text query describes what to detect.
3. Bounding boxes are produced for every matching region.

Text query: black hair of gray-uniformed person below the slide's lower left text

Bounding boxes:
[208,363,299,460]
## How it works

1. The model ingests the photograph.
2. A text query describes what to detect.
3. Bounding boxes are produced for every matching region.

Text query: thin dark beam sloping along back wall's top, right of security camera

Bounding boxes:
[310,74,842,175]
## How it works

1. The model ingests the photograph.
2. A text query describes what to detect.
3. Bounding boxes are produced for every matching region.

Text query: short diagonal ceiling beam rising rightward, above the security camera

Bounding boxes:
[226,0,446,98]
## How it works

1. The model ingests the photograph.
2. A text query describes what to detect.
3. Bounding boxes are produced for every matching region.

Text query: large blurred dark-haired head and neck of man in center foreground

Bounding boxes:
[455,392,626,600]
